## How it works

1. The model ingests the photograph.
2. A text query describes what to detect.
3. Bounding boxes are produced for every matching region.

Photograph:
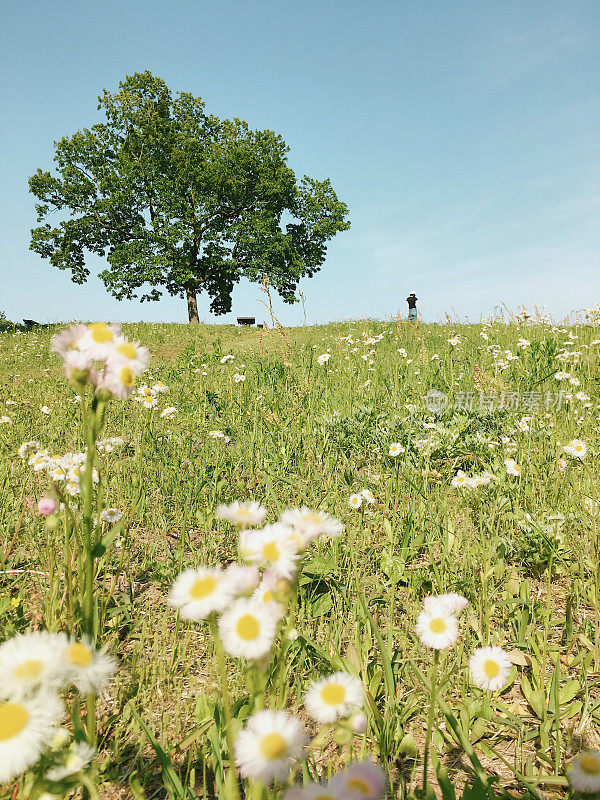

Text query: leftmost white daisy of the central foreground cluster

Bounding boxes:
[169,566,235,621]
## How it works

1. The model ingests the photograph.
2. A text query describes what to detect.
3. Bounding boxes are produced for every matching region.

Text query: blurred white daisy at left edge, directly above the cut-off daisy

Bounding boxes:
[0,631,65,700]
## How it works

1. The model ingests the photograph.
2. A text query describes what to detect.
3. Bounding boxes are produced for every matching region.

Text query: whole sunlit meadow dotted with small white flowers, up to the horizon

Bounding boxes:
[0,308,600,800]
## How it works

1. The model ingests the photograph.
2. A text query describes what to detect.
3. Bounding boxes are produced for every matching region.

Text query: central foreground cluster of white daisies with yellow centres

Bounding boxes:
[169,501,385,800]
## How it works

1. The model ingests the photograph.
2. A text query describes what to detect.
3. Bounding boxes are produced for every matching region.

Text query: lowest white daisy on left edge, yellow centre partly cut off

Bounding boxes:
[0,692,63,784]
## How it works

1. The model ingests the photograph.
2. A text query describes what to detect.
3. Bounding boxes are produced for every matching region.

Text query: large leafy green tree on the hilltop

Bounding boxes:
[29,71,350,322]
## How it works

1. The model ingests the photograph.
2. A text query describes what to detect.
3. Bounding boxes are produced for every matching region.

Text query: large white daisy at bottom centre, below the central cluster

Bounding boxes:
[235,711,308,784]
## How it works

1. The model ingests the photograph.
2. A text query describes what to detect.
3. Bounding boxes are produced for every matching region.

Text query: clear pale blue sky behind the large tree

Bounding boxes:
[0,0,600,325]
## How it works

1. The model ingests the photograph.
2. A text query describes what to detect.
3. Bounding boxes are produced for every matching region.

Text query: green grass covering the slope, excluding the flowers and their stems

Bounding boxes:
[0,321,600,798]
